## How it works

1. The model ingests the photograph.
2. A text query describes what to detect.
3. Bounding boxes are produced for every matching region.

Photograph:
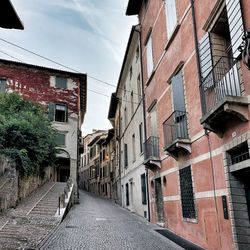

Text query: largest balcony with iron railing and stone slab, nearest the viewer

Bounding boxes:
[200,57,249,137]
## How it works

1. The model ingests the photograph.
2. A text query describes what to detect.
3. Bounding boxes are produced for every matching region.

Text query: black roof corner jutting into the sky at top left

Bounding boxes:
[0,0,24,30]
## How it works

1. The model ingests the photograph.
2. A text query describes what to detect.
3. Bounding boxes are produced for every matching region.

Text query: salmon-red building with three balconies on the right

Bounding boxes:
[126,0,250,249]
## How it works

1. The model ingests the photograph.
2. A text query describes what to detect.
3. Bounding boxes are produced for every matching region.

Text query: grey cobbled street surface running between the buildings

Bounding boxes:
[38,191,182,250]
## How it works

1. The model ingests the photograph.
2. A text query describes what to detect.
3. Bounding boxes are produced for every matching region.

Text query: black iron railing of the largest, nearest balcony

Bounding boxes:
[201,57,241,114]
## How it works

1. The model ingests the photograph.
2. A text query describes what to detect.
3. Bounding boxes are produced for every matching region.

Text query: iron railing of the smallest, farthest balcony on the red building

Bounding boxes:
[144,136,160,160]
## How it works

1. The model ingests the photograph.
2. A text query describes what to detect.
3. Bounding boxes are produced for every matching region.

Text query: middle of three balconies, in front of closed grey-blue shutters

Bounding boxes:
[163,111,191,158]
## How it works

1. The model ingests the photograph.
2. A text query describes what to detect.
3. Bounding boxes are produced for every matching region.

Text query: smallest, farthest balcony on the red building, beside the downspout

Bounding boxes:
[144,136,161,168]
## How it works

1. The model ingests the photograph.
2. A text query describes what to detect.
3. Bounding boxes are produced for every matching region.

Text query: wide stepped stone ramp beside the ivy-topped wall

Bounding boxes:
[0,182,65,250]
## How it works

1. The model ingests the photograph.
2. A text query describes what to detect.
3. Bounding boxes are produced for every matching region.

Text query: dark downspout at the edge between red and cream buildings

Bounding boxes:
[135,25,151,221]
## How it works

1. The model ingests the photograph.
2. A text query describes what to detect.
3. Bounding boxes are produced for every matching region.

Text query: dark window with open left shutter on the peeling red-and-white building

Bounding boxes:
[48,103,68,122]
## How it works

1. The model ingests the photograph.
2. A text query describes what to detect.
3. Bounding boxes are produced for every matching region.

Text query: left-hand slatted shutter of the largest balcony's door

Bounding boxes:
[199,33,213,79]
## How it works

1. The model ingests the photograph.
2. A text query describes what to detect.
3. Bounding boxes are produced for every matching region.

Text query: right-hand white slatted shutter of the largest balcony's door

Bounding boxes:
[226,0,244,58]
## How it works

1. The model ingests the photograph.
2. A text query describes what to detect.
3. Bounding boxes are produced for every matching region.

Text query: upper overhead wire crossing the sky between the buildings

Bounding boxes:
[0,38,141,96]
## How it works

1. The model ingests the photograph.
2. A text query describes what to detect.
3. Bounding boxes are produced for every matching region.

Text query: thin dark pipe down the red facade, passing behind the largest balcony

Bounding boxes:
[190,0,222,247]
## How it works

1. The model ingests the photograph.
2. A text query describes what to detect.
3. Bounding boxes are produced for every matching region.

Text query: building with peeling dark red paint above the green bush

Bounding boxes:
[0,59,87,192]
